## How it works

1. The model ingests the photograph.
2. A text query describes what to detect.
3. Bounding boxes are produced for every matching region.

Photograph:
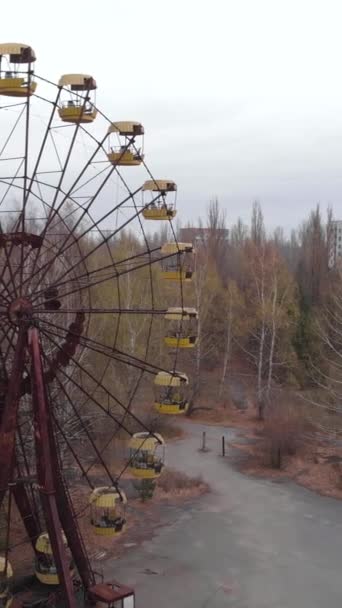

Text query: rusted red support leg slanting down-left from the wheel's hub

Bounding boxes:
[0,324,27,506]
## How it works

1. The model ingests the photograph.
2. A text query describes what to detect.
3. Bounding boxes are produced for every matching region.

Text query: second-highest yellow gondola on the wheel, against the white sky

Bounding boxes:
[58,74,97,124]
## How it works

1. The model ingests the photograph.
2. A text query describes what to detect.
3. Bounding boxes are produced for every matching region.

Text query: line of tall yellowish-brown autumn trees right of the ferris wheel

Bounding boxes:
[180,200,342,419]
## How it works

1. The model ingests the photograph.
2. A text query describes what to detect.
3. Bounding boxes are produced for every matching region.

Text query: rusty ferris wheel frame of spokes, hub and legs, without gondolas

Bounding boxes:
[0,47,188,607]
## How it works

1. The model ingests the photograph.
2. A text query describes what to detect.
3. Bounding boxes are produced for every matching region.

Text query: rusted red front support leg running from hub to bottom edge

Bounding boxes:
[28,328,76,608]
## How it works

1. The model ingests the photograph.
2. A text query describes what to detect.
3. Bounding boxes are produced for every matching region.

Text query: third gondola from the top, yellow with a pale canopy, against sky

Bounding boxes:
[107,121,144,167]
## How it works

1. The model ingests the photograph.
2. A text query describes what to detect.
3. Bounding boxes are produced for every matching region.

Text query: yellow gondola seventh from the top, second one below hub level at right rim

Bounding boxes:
[154,372,189,415]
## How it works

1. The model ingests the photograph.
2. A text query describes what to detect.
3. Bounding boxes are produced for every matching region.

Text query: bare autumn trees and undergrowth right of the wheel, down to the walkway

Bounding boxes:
[182,201,342,487]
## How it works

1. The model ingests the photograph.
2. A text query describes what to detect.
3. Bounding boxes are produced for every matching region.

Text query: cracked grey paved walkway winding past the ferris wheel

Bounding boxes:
[104,423,342,608]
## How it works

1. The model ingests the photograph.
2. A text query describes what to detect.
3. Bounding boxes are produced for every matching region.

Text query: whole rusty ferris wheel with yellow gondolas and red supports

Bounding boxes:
[0,43,197,608]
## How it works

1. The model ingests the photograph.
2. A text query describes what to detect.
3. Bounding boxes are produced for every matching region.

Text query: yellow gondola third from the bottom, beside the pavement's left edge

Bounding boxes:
[89,486,127,536]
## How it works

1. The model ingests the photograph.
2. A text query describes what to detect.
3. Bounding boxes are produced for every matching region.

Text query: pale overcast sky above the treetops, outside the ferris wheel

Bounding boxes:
[1,0,342,233]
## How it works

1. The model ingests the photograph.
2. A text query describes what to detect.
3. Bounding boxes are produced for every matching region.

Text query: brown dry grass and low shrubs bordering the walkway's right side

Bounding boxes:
[184,374,342,499]
